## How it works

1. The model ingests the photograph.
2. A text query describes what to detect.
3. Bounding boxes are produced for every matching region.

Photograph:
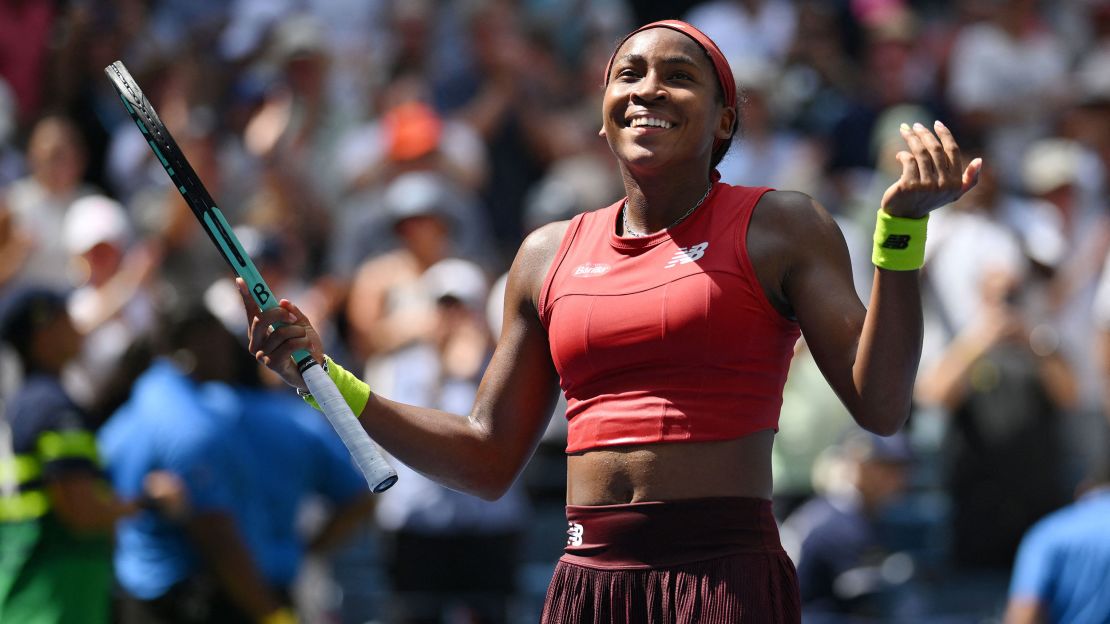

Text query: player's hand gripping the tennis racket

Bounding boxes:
[235,278,324,391]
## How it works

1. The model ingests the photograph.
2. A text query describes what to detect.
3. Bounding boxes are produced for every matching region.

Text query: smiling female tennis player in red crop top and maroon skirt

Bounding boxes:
[241,21,982,623]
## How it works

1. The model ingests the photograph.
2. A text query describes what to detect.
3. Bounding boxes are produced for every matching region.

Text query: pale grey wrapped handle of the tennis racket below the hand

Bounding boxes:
[301,359,397,494]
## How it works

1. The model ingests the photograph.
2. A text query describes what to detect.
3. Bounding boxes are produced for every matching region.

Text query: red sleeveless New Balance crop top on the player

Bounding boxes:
[539,183,799,453]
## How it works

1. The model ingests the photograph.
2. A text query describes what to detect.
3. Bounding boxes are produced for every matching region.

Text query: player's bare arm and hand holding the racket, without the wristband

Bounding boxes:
[246,222,567,500]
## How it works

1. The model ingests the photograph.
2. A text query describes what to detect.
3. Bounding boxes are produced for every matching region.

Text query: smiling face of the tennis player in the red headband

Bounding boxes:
[602,28,736,172]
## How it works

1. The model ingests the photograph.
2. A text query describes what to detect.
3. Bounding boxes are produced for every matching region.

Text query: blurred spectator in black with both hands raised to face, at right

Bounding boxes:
[916,270,1077,575]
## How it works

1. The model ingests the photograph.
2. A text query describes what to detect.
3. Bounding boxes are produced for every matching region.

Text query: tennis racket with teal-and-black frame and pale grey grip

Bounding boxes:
[104,61,397,492]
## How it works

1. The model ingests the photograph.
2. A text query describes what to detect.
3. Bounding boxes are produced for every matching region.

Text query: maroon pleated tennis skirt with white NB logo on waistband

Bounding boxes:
[542,497,801,624]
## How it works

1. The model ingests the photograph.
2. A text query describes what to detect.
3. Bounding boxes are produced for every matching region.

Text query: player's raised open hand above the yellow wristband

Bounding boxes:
[882,121,982,219]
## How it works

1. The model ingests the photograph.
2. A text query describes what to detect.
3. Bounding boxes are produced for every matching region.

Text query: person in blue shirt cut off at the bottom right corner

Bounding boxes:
[1005,453,1110,624]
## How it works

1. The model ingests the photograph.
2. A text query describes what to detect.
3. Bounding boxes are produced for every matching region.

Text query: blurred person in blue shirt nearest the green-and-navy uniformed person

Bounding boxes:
[99,308,295,624]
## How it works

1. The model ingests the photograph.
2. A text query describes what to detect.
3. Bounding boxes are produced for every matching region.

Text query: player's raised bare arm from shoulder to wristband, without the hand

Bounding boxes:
[768,193,921,435]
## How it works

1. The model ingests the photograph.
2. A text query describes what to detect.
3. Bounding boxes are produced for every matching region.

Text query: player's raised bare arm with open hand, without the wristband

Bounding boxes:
[768,122,982,435]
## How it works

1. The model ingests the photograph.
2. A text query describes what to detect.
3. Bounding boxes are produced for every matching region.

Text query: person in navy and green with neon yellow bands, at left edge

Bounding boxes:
[0,286,185,624]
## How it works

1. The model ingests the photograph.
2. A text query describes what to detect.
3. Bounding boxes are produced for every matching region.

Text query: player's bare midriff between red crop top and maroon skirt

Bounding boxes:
[566,430,775,505]
